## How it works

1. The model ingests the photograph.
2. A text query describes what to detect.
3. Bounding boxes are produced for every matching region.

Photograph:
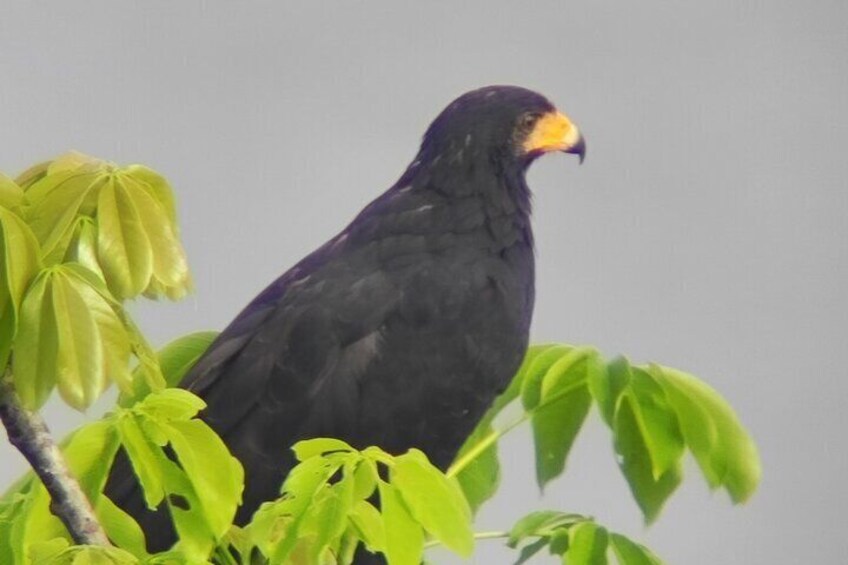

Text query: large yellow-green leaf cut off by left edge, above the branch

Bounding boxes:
[0,207,41,368]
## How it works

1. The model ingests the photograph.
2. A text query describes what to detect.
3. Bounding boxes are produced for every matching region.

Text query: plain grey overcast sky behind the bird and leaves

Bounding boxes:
[0,0,848,565]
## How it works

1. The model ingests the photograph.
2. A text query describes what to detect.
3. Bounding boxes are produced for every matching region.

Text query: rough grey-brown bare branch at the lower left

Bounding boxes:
[0,377,111,545]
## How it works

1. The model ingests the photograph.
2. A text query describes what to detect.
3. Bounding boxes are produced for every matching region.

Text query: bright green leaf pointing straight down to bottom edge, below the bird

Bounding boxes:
[377,481,424,565]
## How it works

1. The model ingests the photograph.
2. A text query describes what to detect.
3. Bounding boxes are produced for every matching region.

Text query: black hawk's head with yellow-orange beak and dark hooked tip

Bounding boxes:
[419,86,586,170]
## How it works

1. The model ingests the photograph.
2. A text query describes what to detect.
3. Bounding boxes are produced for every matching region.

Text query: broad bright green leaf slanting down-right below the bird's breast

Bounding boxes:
[391,449,474,557]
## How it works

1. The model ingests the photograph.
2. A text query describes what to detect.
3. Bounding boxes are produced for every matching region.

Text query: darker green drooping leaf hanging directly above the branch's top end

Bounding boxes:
[12,271,59,410]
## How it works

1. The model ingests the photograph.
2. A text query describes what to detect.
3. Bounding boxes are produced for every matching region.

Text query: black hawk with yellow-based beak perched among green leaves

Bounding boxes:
[106,85,586,562]
